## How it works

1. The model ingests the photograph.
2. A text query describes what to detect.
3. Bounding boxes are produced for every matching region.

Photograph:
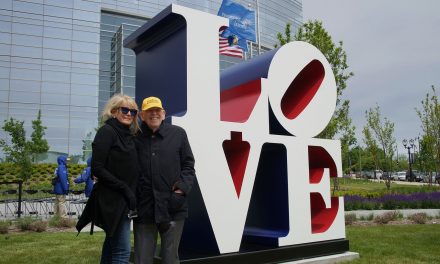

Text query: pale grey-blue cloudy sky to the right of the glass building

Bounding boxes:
[302,0,440,154]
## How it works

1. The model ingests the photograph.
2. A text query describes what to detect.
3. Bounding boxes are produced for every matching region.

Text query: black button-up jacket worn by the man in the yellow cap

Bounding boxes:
[135,122,196,223]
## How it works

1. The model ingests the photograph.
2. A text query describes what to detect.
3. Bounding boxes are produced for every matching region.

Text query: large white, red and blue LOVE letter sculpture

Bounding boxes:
[125,5,348,263]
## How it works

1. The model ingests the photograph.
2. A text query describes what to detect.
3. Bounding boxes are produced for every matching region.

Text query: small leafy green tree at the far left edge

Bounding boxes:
[0,117,32,181]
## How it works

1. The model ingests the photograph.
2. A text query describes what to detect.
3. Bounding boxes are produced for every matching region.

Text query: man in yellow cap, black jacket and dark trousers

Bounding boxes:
[133,97,195,264]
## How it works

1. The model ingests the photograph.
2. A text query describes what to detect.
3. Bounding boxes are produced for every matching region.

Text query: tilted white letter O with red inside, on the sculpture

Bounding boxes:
[263,41,337,137]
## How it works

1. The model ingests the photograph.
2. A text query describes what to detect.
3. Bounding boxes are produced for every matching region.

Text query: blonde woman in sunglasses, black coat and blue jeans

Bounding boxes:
[76,94,139,263]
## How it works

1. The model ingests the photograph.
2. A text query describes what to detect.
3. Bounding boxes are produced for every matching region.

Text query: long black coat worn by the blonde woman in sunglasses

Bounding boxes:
[76,118,139,237]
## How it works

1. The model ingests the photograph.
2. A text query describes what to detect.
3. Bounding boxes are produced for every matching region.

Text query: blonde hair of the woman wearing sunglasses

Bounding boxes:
[101,94,139,134]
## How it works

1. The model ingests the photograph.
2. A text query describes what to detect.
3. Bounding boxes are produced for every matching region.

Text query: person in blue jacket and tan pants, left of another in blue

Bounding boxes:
[53,156,69,218]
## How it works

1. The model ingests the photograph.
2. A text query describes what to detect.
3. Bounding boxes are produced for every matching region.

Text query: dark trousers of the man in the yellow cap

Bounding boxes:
[133,220,185,264]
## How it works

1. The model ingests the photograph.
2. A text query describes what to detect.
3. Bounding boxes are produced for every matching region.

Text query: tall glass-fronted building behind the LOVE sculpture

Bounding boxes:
[0,0,302,162]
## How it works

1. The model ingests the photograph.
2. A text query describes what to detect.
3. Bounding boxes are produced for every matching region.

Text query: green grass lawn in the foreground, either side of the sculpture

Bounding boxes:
[0,224,440,264]
